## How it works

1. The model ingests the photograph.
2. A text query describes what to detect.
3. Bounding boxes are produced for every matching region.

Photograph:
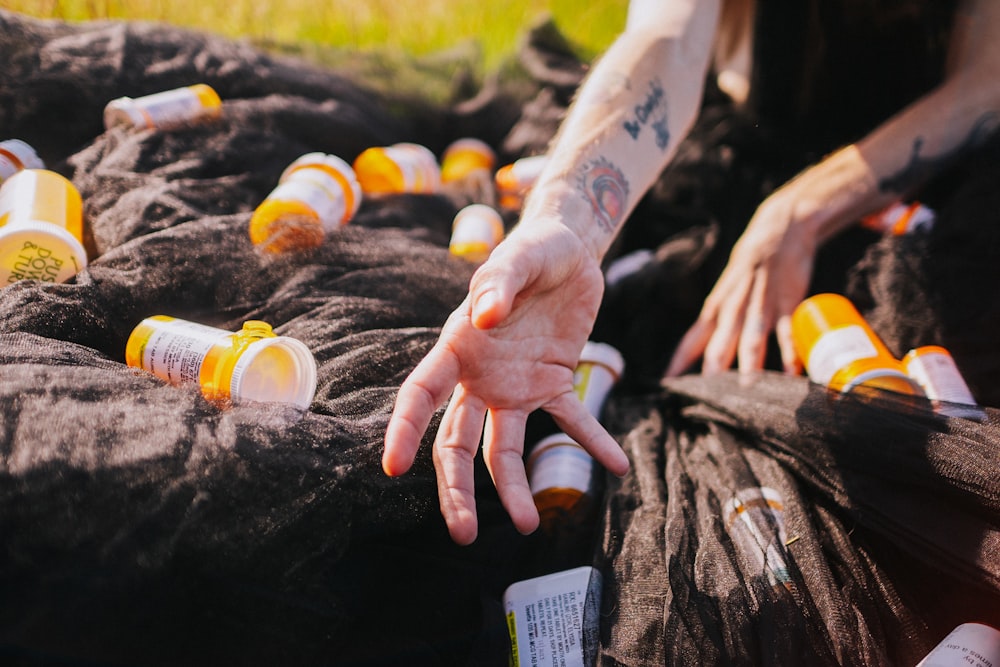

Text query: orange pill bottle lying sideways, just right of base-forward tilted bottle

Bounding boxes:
[353,142,441,196]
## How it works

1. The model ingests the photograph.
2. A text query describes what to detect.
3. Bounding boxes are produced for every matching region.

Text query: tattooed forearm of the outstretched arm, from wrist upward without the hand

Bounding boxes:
[515,0,718,258]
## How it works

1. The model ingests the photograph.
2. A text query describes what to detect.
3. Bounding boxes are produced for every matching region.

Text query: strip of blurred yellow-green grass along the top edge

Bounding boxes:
[4,0,628,70]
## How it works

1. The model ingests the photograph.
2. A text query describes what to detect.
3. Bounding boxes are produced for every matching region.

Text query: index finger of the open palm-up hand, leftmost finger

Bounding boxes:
[382,341,459,477]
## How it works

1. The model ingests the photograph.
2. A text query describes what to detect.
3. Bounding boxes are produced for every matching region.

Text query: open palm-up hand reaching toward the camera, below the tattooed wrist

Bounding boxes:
[382,223,628,544]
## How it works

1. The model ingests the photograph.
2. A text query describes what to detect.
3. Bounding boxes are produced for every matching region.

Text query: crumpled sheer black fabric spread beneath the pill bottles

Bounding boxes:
[0,12,1000,665]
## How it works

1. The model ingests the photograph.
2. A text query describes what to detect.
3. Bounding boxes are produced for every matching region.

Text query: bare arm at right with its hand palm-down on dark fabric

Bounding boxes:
[667,0,1000,376]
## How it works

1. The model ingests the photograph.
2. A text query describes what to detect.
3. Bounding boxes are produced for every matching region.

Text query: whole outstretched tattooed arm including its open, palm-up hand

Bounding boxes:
[382,0,719,544]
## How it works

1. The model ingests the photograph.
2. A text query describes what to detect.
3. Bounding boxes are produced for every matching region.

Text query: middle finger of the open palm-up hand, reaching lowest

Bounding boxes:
[433,385,486,545]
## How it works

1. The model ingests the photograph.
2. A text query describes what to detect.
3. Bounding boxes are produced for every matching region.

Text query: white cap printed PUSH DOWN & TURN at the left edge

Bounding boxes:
[0,220,87,287]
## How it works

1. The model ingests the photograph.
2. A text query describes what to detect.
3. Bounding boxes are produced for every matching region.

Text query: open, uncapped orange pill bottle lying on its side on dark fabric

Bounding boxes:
[125,315,316,410]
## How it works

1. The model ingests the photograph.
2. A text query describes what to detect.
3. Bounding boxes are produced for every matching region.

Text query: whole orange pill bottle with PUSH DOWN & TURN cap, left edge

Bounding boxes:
[0,169,87,286]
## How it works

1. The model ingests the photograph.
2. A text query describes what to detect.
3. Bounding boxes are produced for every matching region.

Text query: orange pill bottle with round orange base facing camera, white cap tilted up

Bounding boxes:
[250,153,361,253]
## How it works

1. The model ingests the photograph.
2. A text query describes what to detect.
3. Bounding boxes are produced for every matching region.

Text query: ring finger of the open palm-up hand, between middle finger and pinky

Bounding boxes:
[483,410,539,535]
